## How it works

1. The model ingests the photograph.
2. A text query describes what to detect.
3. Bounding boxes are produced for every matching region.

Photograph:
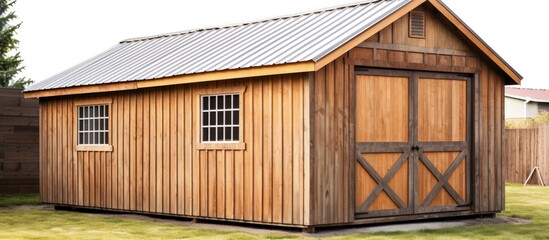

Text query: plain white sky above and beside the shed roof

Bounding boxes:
[12,0,549,89]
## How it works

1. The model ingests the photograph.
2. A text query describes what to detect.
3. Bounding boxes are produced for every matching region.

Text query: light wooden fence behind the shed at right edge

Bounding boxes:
[504,124,549,184]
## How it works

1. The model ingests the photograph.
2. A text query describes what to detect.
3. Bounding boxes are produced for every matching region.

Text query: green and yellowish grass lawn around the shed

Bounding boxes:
[0,184,549,239]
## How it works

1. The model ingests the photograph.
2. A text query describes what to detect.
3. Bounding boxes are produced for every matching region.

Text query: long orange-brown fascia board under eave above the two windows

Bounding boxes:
[24,61,315,98]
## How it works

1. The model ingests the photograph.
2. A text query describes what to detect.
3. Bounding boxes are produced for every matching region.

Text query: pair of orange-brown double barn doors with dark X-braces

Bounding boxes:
[355,70,471,218]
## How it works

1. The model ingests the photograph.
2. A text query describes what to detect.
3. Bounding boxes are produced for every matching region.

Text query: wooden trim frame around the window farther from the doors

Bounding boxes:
[73,97,113,152]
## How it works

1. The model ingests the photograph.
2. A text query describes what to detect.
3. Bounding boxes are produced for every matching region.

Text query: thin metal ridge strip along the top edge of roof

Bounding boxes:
[119,0,386,43]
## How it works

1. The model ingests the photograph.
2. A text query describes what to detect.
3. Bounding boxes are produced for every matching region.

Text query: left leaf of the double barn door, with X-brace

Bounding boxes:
[355,75,413,217]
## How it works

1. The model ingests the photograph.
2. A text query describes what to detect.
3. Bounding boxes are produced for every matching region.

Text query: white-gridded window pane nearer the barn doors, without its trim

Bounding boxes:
[200,93,240,143]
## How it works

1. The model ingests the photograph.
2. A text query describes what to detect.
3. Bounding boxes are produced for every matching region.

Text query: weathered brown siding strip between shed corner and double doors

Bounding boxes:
[311,58,355,224]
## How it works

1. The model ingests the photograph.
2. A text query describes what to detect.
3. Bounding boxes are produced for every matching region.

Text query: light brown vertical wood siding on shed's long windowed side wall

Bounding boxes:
[40,74,310,225]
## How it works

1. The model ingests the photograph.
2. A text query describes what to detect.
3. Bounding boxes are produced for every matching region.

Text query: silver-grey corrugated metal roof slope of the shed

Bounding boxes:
[25,0,411,92]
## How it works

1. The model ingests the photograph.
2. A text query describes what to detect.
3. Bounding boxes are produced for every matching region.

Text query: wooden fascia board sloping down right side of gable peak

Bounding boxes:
[427,0,522,84]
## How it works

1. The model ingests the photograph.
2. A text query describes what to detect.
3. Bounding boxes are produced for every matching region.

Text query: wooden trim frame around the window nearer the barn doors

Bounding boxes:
[193,86,246,150]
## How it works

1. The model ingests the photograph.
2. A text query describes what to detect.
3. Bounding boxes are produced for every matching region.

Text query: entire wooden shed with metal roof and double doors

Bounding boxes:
[25,0,521,230]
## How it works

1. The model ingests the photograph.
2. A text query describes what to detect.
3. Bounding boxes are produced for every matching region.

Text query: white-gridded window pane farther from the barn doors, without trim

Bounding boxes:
[78,105,109,145]
